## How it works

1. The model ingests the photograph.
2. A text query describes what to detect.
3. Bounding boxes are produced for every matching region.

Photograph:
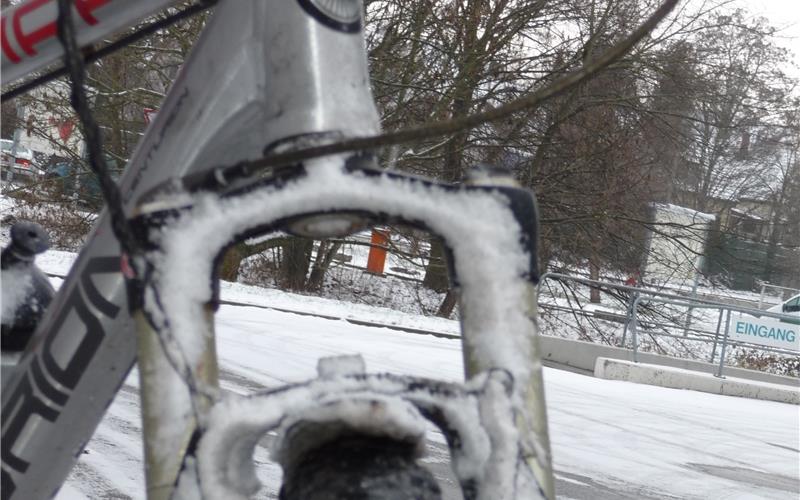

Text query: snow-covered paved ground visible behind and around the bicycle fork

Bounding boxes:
[47,276,800,500]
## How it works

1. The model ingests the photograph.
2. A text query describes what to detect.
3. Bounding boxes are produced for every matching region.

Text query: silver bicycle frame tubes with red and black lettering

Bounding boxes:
[2,0,553,499]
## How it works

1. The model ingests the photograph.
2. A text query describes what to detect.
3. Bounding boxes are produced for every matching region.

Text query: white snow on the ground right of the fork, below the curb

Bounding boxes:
[545,372,798,498]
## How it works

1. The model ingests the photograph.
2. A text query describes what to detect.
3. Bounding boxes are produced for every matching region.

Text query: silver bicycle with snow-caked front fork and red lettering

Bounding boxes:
[2,0,674,499]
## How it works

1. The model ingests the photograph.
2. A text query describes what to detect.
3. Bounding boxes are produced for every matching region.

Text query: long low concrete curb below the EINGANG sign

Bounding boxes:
[594,357,800,405]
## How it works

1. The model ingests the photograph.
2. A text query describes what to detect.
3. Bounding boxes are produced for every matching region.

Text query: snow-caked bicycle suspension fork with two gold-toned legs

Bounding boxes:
[131,156,553,499]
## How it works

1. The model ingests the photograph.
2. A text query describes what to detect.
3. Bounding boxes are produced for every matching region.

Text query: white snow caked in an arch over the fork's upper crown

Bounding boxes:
[150,154,538,388]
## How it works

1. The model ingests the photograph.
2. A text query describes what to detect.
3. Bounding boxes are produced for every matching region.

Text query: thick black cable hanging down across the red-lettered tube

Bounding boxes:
[56,0,140,255]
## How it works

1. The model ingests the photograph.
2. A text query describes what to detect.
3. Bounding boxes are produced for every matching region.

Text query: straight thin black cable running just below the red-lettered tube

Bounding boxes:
[0,0,219,102]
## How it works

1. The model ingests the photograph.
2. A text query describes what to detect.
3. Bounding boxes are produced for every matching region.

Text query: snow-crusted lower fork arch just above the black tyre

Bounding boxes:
[197,371,542,500]
